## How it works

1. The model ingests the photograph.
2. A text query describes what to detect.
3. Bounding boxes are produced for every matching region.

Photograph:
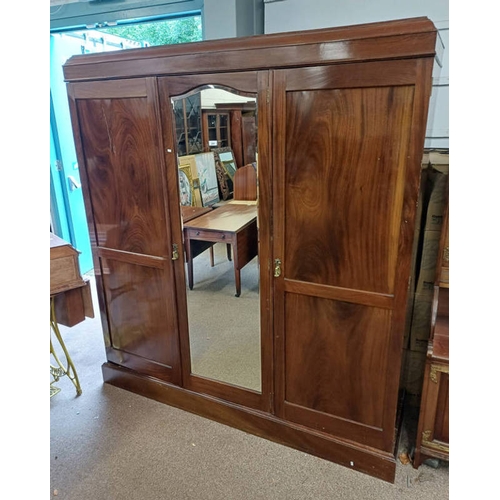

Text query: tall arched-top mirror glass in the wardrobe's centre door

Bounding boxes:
[172,85,261,392]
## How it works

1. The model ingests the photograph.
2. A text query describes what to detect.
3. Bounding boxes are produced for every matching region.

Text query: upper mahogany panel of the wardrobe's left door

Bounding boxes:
[77,97,168,257]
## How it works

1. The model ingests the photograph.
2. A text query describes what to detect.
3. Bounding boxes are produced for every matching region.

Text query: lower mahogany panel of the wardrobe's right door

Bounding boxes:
[285,294,390,432]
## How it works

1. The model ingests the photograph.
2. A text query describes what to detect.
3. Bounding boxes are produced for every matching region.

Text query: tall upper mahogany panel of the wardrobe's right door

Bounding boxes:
[285,86,413,294]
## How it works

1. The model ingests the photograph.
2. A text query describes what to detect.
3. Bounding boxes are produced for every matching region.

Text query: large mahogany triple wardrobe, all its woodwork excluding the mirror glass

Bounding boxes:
[64,18,436,481]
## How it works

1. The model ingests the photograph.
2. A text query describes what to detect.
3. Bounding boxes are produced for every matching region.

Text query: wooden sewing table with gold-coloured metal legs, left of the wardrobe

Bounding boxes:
[50,233,94,397]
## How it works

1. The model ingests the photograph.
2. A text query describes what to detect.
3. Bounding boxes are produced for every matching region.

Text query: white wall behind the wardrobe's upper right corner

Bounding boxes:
[264,0,449,148]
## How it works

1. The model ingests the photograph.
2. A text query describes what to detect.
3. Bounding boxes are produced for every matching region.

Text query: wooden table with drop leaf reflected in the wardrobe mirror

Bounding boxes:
[184,204,258,297]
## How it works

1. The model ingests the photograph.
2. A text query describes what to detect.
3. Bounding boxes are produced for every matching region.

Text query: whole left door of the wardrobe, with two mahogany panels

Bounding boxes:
[68,78,182,383]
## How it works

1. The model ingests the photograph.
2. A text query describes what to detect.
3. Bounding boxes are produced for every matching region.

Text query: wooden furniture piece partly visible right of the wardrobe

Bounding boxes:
[413,200,450,468]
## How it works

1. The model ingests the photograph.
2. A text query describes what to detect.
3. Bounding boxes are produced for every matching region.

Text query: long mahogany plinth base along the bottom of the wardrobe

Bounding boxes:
[102,363,396,483]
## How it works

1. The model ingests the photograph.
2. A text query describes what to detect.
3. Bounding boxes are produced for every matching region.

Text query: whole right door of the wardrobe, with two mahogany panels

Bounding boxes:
[273,60,434,452]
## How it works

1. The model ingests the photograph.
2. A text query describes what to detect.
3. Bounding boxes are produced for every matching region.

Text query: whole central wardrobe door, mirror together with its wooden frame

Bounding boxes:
[159,72,272,411]
